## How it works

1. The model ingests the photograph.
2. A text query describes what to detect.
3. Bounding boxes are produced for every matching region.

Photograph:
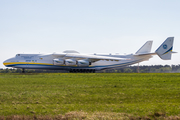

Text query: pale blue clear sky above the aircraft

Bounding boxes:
[0,0,180,68]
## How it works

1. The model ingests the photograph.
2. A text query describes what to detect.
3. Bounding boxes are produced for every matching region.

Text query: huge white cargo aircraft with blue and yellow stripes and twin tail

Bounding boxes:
[3,37,175,72]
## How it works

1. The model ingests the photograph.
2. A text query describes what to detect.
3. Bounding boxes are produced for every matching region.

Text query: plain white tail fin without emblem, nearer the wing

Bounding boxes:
[136,41,153,54]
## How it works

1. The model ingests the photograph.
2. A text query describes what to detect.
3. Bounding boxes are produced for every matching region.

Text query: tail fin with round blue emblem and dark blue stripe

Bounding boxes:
[155,37,174,60]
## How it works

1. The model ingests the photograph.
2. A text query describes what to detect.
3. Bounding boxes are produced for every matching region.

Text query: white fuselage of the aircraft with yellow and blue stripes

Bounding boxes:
[4,53,151,70]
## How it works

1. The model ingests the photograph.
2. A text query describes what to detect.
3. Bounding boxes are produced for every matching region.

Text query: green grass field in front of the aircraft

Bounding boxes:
[0,73,180,118]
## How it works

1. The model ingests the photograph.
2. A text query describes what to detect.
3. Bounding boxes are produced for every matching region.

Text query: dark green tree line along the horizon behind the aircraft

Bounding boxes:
[0,65,180,73]
